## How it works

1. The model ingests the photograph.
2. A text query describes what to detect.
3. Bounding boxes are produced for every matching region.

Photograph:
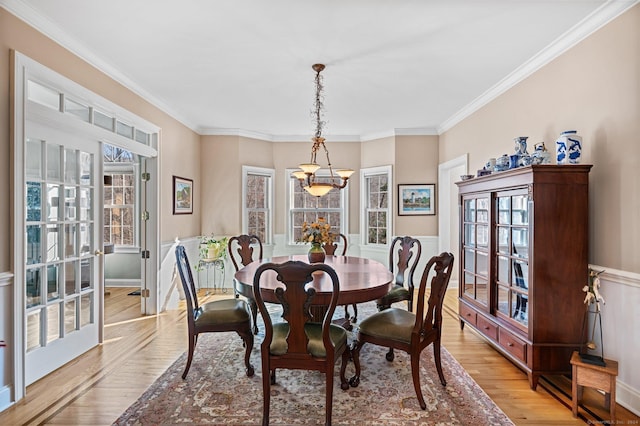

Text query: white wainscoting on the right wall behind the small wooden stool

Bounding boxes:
[591,265,640,416]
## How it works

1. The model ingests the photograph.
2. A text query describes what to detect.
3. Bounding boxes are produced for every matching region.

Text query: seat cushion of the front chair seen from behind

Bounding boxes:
[269,322,347,358]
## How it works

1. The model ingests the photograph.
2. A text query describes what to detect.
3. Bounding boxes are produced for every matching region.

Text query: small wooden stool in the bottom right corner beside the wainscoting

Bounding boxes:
[571,351,618,423]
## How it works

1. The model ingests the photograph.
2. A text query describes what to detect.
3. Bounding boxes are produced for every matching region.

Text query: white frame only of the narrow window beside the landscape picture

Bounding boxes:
[360,165,394,248]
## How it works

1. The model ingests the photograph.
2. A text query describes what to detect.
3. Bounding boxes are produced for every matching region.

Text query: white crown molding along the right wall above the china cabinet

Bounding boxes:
[438,0,640,134]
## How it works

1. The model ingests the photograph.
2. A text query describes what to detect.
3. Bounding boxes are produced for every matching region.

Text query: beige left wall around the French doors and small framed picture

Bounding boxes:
[0,8,200,271]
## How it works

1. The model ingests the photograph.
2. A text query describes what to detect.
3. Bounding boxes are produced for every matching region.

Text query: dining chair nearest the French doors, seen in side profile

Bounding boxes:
[176,244,254,379]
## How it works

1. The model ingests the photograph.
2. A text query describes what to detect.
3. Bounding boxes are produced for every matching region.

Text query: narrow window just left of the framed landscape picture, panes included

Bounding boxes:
[360,166,392,245]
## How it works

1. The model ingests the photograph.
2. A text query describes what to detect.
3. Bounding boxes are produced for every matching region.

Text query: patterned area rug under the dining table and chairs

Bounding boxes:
[114,304,513,425]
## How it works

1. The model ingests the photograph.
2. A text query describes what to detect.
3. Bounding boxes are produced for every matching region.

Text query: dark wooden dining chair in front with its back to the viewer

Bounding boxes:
[253,261,351,425]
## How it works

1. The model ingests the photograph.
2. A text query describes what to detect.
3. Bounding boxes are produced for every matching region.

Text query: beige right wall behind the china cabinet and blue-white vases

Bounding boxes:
[440,5,640,273]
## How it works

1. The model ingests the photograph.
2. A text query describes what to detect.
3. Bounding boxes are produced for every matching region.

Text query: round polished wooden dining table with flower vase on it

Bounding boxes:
[235,255,393,305]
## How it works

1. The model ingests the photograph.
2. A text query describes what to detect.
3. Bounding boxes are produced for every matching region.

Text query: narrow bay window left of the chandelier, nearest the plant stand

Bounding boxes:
[242,166,274,244]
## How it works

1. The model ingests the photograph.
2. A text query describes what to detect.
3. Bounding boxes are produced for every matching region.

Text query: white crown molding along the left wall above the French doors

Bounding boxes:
[0,0,196,131]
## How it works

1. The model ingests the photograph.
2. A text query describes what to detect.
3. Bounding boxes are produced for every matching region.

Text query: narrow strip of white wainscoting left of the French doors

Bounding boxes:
[0,272,15,411]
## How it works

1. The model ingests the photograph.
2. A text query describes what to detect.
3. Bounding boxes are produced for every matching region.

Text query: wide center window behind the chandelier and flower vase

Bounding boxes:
[287,170,349,244]
